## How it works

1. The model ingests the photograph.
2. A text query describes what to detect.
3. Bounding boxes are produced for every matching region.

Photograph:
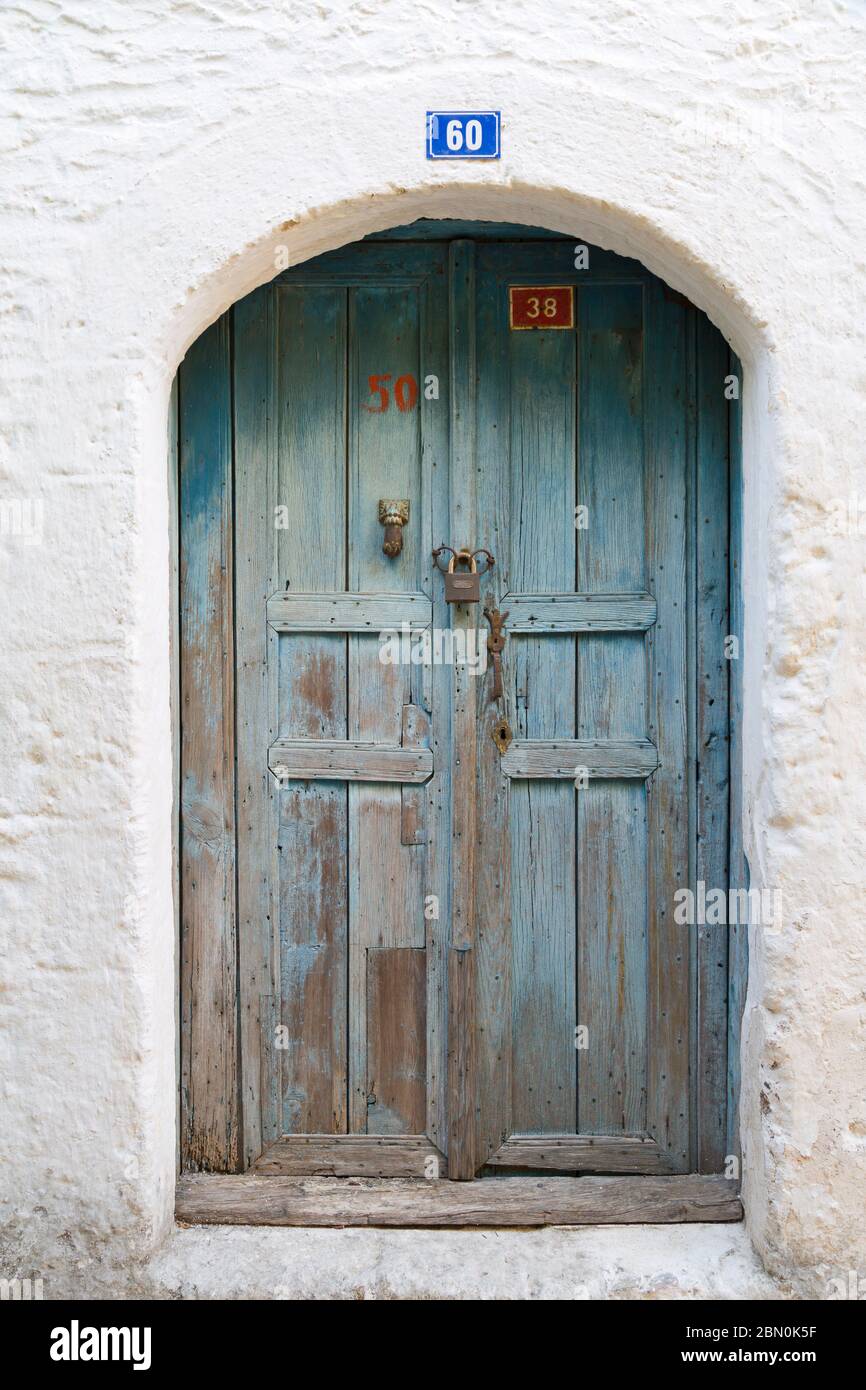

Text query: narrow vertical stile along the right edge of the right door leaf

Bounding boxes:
[645,281,691,1172]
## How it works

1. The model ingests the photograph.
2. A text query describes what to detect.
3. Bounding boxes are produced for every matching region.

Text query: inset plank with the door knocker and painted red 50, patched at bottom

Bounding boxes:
[348,284,432,1134]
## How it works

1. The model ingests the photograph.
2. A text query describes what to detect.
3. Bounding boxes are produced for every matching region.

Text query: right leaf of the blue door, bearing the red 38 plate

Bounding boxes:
[477,246,724,1170]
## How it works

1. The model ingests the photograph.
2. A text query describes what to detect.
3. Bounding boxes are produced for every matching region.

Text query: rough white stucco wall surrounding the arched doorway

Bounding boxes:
[0,0,866,1297]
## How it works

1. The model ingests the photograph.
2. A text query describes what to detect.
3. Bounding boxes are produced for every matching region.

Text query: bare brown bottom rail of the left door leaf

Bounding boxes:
[253,1134,448,1177]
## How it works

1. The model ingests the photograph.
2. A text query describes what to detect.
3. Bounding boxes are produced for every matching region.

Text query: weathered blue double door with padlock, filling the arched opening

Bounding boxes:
[179,224,735,1179]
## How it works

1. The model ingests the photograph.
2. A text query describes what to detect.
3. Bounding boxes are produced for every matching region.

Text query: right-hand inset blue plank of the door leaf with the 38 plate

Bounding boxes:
[577,285,647,1134]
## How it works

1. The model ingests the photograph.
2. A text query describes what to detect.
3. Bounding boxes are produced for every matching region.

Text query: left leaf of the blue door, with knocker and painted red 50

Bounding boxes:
[235,249,448,1172]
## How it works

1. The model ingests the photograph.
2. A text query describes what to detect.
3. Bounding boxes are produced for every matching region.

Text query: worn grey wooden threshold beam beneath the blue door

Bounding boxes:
[175,1173,742,1226]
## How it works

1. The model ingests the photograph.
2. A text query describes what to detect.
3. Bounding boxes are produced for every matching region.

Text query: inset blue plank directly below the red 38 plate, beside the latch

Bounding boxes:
[500,276,577,1134]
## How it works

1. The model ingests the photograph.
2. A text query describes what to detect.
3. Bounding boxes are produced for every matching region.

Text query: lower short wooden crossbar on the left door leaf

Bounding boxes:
[268,738,432,783]
